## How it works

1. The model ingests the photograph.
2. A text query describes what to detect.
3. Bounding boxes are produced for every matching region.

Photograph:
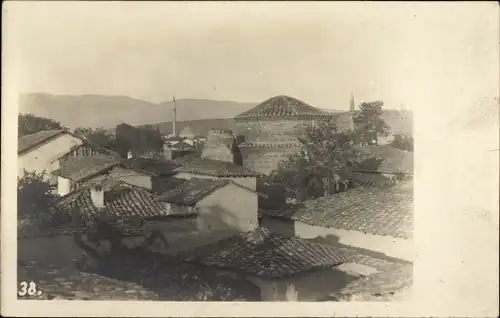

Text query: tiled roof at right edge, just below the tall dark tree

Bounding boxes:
[356,146,414,174]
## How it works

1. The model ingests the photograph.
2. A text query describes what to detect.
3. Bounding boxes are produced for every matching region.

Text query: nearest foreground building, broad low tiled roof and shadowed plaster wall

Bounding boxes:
[180,228,357,301]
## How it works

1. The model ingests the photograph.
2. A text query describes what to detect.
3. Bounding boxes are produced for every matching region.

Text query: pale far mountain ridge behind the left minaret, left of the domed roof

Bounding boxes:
[19,93,255,128]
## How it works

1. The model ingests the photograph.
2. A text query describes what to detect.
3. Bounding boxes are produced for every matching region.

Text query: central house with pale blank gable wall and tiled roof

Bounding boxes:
[160,178,259,232]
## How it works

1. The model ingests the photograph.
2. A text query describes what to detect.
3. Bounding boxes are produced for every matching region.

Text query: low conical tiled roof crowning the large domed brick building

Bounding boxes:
[236,95,330,119]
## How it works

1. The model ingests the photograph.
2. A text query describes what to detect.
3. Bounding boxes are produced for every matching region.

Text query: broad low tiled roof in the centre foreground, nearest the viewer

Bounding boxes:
[182,228,346,278]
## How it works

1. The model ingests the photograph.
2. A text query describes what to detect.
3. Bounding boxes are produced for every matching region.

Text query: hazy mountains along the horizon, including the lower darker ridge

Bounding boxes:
[19,93,413,135]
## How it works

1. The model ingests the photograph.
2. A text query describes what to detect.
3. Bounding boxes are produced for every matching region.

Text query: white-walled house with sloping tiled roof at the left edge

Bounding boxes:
[18,130,118,185]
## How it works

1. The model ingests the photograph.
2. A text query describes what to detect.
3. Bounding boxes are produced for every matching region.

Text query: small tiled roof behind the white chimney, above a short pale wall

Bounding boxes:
[54,156,120,181]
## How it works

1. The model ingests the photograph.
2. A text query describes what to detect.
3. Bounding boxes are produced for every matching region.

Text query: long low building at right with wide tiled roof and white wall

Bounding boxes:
[261,181,414,261]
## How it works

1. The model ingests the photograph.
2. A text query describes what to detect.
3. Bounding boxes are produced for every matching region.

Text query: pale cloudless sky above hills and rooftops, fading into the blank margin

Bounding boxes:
[3,1,499,109]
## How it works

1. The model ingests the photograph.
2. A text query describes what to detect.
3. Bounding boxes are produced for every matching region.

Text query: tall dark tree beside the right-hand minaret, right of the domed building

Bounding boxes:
[353,101,389,144]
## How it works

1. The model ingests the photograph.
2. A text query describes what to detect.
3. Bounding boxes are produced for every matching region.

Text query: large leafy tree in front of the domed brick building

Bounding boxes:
[273,120,360,202]
